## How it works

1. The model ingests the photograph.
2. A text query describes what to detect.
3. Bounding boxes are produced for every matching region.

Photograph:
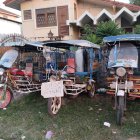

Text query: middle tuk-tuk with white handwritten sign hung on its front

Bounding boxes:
[41,40,100,115]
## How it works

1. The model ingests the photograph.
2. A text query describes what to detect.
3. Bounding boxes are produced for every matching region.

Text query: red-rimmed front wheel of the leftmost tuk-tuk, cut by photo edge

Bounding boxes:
[0,88,12,109]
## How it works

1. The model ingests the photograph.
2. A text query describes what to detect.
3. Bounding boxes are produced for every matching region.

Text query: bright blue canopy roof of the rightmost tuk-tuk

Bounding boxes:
[103,34,140,43]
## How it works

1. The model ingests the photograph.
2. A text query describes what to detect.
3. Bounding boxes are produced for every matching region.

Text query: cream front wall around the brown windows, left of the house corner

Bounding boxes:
[21,0,73,39]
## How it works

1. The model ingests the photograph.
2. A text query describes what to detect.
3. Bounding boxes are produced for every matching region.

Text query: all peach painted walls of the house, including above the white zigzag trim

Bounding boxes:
[18,0,137,40]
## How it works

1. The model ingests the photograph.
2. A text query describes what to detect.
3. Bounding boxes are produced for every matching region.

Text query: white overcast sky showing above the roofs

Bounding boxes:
[0,0,129,15]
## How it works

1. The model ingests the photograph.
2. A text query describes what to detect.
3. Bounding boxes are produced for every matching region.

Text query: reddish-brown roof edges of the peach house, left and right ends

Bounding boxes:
[4,0,140,11]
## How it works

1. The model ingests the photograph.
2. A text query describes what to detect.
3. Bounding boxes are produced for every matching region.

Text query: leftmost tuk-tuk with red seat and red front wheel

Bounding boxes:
[0,42,43,109]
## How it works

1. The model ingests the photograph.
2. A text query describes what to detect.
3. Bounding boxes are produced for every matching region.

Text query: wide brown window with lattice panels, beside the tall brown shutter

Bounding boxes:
[36,7,57,27]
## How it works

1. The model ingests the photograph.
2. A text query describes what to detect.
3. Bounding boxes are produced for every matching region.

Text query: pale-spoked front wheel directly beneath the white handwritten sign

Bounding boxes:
[48,97,61,116]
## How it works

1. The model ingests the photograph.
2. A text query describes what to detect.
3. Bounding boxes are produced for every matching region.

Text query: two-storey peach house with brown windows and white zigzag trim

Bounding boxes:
[4,0,140,39]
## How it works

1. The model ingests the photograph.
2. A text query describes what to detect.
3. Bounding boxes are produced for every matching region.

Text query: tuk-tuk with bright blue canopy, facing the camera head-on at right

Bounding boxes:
[104,34,140,125]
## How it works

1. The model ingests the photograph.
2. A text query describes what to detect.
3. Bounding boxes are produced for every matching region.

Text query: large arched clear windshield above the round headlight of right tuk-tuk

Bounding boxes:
[108,43,138,68]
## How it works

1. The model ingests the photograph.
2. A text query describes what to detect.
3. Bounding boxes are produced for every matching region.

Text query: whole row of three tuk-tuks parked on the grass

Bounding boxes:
[0,34,140,125]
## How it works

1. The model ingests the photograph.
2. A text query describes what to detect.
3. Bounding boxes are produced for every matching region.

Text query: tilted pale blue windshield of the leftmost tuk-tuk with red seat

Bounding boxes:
[0,50,18,68]
